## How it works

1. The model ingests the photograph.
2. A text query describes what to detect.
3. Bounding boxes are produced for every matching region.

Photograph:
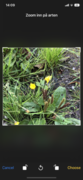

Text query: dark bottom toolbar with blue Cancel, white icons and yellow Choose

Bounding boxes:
[1,162,82,180]
